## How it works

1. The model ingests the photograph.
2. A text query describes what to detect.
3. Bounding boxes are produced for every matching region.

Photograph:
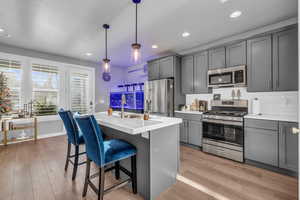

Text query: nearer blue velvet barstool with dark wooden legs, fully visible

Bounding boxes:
[75,115,137,200]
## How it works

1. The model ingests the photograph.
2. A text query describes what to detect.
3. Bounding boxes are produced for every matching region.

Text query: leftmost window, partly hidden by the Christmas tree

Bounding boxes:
[0,59,21,111]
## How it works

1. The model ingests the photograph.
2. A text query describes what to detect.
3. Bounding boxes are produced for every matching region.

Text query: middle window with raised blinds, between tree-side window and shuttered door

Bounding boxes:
[32,64,59,116]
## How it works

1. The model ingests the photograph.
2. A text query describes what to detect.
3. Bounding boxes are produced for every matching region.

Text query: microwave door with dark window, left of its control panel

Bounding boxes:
[208,72,233,87]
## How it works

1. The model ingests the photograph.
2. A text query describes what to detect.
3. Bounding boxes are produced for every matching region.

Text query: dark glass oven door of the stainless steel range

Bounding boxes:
[203,121,244,146]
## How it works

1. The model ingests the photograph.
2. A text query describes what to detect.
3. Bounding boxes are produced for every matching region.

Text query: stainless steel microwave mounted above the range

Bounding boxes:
[207,65,247,88]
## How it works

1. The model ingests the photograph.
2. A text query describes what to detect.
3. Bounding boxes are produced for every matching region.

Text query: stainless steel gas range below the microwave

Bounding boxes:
[202,100,248,162]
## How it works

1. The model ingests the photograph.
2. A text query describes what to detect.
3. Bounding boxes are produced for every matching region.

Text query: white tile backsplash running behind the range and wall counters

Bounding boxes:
[186,88,298,116]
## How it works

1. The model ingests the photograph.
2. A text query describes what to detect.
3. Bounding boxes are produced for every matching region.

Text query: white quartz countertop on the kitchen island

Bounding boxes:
[95,112,182,135]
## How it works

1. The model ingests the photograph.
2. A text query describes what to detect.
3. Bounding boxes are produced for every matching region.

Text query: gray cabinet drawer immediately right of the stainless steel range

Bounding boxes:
[245,119,278,131]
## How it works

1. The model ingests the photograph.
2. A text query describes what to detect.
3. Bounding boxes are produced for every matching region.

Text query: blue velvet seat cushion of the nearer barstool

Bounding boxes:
[103,139,136,165]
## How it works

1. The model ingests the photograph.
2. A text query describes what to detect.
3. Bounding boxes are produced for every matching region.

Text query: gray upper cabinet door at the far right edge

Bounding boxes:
[273,29,298,91]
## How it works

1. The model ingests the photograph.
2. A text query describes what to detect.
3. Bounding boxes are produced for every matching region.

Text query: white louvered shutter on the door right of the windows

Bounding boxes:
[71,72,89,114]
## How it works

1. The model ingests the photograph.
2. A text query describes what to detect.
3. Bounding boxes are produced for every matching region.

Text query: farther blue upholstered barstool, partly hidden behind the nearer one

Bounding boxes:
[58,109,86,180]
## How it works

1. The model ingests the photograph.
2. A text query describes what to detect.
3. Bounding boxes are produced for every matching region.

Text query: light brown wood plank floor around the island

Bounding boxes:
[0,136,298,200]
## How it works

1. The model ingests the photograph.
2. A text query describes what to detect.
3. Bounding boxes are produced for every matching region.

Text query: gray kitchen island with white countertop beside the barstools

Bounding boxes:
[95,112,182,200]
